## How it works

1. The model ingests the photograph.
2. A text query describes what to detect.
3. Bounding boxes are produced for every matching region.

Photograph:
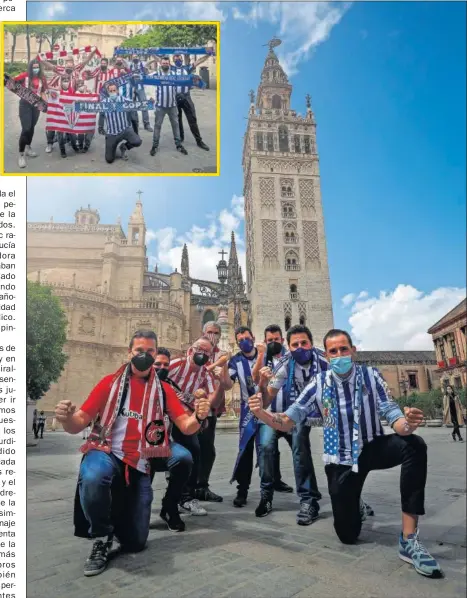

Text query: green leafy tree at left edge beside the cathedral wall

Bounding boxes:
[26,280,67,401]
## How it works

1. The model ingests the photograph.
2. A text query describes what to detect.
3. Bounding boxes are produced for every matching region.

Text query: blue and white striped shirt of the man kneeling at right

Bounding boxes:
[285,366,404,465]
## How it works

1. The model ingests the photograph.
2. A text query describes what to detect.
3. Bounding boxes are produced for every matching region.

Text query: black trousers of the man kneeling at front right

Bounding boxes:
[325,434,427,544]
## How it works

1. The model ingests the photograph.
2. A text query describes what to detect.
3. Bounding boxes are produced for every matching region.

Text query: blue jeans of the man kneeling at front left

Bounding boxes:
[78,450,153,552]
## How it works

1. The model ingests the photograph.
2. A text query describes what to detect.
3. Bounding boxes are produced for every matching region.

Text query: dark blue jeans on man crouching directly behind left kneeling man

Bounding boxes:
[149,442,193,509]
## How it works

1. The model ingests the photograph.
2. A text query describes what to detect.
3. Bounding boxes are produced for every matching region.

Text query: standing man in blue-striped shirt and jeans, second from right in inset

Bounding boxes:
[149,56,188,156]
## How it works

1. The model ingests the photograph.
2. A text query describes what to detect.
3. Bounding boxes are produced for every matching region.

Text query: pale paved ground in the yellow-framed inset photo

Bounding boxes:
[4,89,217,175]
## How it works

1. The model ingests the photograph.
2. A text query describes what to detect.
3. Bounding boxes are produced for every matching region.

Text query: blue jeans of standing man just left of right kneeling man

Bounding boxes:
[259,424,321,504]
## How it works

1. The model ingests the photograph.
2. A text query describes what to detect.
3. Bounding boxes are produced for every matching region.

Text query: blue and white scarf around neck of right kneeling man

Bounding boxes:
[322,365,364,472]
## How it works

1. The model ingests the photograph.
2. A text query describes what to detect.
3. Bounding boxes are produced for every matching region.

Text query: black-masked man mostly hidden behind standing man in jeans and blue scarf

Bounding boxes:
[252,324,293,493]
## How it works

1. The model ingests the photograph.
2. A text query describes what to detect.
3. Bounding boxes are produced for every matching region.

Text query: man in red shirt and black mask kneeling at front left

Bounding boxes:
[55,330,210,576]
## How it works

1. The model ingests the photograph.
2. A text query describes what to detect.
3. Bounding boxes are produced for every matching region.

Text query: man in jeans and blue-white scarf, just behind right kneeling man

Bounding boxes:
[254,324,328,525]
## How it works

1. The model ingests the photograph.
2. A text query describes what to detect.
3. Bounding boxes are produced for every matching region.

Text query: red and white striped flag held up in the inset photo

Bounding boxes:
[46,90,99,134]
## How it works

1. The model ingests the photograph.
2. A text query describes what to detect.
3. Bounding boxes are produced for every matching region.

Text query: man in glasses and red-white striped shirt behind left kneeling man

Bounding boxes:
[169,338,222,515]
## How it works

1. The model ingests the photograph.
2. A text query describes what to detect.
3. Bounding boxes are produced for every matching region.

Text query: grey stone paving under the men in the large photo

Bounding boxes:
[27,428,466,598]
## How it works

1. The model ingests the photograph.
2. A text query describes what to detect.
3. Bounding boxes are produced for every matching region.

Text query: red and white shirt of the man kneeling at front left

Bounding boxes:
[81,374,185,473]
